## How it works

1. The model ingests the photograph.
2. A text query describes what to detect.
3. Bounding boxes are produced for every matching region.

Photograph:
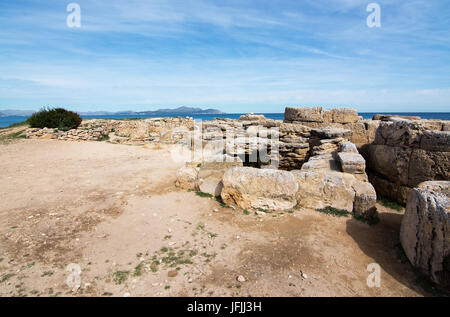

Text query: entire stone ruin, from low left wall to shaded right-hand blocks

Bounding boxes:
[21,107,450,288]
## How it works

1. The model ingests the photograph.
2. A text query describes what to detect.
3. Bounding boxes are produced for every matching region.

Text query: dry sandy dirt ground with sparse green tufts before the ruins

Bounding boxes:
[0,140,436,296]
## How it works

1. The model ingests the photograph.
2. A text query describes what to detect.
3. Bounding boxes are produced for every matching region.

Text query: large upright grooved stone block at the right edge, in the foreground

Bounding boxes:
[400,181,450,288]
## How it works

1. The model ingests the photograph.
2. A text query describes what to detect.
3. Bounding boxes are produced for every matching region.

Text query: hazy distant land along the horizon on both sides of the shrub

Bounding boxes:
[0,107,224,117]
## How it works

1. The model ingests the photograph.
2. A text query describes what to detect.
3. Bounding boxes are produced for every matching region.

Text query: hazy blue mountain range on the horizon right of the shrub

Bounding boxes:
[80,107,223,116]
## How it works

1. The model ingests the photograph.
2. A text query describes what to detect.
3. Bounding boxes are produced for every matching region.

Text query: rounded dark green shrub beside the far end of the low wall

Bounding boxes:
[27,108,82,131]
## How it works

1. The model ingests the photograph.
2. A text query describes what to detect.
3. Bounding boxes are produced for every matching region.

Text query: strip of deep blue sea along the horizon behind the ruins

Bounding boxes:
[0,112,450,128]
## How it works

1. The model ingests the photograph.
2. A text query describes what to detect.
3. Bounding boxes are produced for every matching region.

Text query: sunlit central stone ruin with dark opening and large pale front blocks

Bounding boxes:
[177,108,377,219]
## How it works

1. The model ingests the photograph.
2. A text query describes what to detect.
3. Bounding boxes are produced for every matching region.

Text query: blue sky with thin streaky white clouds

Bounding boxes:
[0,0,450,113]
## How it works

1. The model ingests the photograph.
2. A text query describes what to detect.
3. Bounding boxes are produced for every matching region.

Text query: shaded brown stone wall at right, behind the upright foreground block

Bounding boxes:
[367,118,450,204]
